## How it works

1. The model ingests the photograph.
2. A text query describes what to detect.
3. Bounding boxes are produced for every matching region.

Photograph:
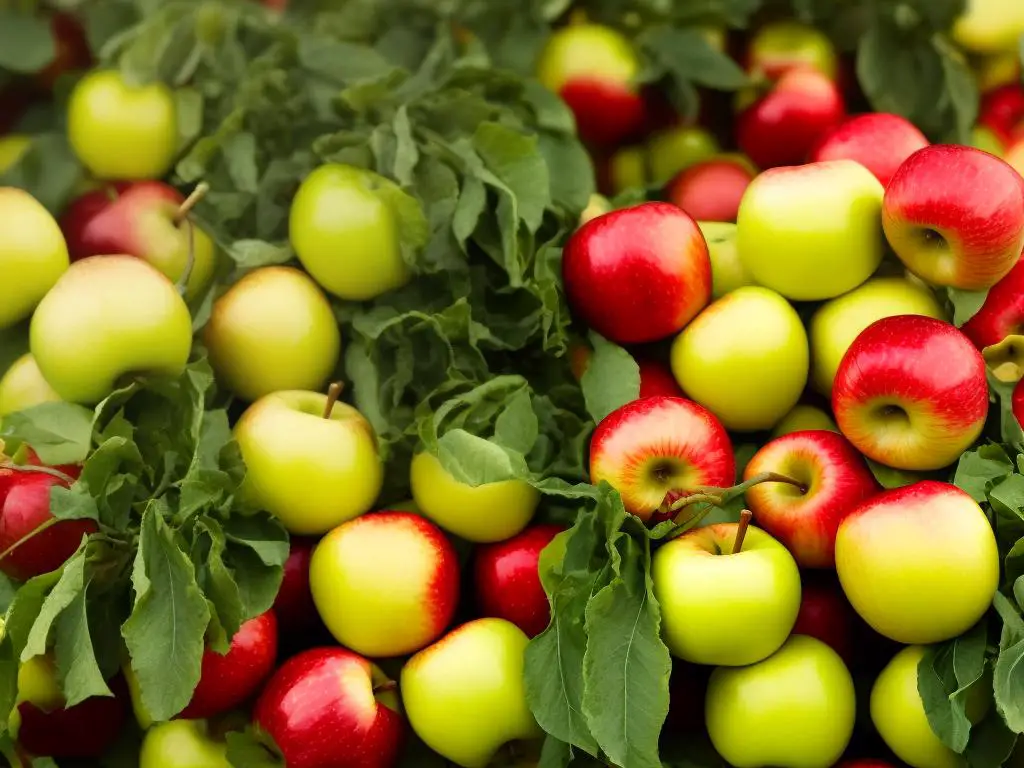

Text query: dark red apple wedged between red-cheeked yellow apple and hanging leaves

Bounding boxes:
[473,523,565,637]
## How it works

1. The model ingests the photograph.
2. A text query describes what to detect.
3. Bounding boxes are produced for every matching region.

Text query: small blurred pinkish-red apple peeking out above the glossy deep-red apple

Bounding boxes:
[665,155,757,221]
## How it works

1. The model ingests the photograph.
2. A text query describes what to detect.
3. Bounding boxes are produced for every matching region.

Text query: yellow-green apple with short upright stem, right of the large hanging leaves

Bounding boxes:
[651,523,800,667]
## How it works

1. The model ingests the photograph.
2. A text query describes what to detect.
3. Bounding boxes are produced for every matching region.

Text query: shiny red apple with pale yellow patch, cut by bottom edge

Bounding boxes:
[253,647,404,768]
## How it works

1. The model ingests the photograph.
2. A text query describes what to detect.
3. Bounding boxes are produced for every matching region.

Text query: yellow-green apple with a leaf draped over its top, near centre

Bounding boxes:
[410,452,541,544]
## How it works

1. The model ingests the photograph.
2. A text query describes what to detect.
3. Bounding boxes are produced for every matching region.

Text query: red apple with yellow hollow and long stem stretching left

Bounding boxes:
[743,430,881,568]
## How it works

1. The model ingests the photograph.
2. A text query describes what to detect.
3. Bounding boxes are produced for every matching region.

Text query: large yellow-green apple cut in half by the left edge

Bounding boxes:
[0,186,70,328]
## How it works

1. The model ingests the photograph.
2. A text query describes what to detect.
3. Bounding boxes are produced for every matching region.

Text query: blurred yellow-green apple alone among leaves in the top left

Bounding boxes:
[68,70,178,180]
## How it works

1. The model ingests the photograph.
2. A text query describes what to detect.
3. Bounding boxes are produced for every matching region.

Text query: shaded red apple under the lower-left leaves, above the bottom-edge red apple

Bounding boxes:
[178,610,278,720]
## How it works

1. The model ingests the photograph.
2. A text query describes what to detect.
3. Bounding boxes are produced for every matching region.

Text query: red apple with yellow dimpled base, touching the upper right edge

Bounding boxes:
[882,144,1024,291]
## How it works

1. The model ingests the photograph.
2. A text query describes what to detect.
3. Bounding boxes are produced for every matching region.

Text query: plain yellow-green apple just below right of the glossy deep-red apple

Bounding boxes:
[672,286,808,431]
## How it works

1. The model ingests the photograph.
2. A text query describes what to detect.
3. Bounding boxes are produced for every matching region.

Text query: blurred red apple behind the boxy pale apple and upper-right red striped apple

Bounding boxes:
[809,112,930,186]
